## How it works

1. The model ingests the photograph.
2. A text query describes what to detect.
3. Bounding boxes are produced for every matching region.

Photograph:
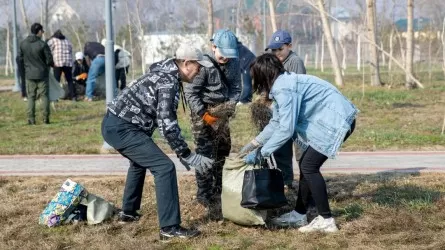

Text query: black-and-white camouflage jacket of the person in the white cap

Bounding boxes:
[108,59,190,155]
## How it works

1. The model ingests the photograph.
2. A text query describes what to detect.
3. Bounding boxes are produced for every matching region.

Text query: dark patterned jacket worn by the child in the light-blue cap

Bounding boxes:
[184,54,241,117]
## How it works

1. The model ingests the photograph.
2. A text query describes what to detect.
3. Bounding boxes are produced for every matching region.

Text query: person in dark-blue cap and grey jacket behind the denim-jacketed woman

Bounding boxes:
[266,30,306,188]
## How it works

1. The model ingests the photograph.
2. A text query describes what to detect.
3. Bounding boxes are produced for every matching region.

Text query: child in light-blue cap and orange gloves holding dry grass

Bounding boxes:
[184,30,241,213]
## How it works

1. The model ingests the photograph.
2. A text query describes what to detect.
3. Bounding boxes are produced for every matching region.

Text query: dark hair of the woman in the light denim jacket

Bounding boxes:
[250,53,286,98]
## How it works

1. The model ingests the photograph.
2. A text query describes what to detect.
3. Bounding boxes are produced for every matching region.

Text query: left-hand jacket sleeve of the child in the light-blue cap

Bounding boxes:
[184,67,208,117]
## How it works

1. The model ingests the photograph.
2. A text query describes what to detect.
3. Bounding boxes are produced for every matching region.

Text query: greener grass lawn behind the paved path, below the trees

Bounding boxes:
[0,72,445,154]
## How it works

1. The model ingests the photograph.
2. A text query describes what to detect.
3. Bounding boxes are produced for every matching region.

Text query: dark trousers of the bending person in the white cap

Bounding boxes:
[102,112,181,228]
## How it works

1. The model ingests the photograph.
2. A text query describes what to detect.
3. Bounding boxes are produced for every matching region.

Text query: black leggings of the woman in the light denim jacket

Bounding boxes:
[295,120,355,218]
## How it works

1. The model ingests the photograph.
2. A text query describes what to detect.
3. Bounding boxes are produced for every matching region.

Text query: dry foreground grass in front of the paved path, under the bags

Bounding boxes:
[0,173,445,250]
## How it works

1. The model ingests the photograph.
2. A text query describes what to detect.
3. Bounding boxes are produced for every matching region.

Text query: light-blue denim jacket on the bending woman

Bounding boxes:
[255,72,359,158]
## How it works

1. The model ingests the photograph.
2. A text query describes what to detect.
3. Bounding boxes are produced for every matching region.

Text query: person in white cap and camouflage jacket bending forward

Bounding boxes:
[102,44,213,240]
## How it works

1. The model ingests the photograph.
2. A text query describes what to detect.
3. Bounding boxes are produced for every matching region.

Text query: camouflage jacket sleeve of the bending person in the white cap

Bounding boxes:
[157,81,190,155]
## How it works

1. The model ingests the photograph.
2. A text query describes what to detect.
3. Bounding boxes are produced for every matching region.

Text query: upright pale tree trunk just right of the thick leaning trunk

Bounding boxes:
[366,0,382,86]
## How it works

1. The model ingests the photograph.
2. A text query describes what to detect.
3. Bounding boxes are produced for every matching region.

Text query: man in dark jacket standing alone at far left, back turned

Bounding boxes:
[19,23,54,125]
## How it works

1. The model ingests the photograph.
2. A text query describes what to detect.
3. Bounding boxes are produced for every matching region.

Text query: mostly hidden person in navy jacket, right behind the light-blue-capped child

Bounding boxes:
[234,40,256,104]
